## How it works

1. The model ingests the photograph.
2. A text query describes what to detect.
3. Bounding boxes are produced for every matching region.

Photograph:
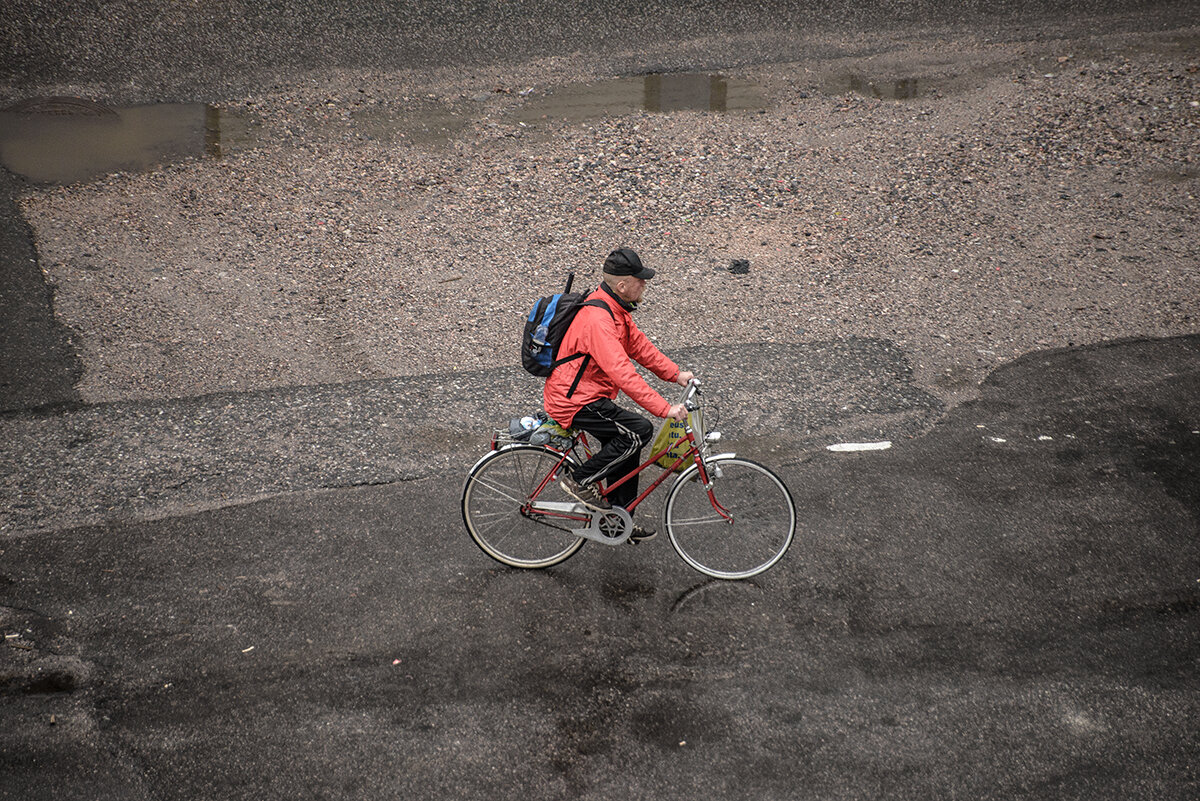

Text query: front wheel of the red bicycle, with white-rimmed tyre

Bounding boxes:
[664,456,796,579]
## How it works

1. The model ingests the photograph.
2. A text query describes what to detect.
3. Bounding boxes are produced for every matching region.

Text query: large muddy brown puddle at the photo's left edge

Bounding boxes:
[0,98,247,183]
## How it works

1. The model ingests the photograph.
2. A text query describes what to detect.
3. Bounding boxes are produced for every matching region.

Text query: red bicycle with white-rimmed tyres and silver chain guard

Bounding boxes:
[462,379,796,579]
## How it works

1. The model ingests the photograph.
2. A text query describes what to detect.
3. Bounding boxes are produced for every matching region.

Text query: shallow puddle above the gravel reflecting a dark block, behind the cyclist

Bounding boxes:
[516,72,767,122]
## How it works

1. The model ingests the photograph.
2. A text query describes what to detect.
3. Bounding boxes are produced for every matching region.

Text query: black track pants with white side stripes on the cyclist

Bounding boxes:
[571,398,654,507]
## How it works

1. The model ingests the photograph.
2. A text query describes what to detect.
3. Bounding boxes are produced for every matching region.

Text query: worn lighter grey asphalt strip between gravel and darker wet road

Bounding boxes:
[0,339,943,535]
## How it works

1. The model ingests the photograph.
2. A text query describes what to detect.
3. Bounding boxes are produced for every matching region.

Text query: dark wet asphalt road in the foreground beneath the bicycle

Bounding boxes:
[0,336,1200,801]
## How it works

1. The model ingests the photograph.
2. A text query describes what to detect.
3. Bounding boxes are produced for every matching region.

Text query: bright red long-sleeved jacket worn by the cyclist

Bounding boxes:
[542,284,679,426]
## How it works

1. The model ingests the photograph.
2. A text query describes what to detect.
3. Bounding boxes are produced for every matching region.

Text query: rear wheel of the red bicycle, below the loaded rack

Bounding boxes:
[462,445,586,568]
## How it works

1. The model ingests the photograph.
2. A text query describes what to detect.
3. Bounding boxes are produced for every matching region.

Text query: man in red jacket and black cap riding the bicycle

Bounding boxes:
[542,247,692,543]
